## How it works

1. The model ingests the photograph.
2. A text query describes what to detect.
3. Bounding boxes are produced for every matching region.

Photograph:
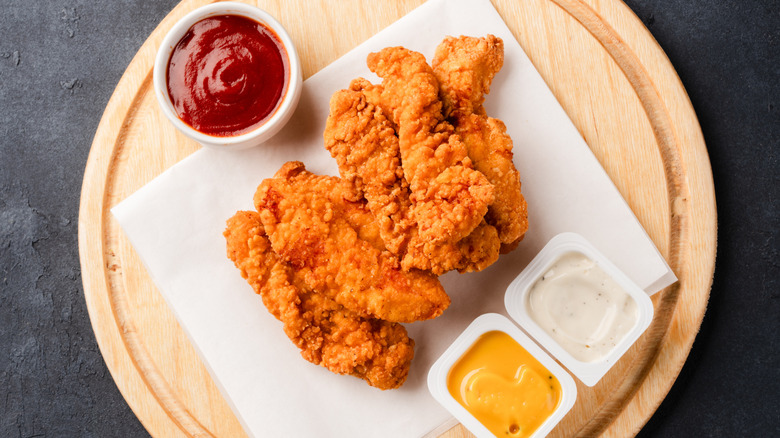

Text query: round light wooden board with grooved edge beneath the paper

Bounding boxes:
[79,0,716,437]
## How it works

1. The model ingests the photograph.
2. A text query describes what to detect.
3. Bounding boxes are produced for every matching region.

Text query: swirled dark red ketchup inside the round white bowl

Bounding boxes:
[168,15,289,137]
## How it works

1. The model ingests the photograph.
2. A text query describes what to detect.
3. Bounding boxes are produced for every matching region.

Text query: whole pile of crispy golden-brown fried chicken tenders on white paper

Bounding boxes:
[224,35,528,389]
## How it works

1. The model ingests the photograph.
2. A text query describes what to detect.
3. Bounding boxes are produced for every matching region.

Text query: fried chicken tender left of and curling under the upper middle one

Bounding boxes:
[324,79,500,275]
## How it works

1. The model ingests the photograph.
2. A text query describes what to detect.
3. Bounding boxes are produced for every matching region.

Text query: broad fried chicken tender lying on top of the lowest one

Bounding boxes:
[254,162,450,322]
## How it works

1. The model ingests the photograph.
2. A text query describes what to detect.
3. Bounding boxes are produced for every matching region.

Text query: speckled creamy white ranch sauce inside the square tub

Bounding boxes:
[526,252,639,362]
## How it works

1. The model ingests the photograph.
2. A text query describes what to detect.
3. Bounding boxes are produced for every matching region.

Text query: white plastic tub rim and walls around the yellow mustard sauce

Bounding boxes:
[428,313,577,438]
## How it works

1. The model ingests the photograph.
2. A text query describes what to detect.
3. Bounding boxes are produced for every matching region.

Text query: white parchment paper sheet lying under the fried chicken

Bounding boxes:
[112,0,676,437]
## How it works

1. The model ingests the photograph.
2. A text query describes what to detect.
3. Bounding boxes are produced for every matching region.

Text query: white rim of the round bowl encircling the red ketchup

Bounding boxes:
[152,2,303,150]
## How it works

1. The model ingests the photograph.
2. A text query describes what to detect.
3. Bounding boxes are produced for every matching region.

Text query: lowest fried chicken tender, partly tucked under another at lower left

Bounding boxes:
[224,211,414,389]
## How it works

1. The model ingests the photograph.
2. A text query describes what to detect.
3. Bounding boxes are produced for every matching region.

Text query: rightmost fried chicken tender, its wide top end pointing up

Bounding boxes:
[433,35,528,252]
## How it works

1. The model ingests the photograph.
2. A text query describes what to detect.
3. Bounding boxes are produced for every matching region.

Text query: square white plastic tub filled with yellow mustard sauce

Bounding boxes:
[428,313,577,438]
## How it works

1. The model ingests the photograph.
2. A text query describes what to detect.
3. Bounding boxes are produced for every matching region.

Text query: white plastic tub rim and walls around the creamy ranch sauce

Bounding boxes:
[504,232,653,386]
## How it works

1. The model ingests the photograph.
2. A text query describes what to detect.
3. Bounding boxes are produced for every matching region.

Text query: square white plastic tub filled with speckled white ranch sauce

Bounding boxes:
[505,233,653,386]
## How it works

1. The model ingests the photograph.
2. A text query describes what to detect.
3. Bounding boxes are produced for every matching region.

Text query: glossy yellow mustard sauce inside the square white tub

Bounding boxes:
[447,331,561,438]
